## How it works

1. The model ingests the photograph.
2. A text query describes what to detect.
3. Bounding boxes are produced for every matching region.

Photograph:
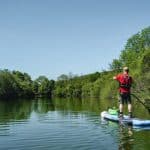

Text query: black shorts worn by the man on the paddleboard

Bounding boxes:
[119,93,131,104]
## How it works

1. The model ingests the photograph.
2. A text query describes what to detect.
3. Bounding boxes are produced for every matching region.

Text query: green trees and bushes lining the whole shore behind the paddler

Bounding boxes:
[0,27,150,99]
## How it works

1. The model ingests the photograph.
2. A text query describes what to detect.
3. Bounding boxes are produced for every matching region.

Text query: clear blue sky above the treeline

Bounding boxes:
[0,0,150,79]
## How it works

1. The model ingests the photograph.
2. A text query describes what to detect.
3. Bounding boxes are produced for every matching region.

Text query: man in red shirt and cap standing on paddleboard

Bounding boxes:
[113,67,133,118]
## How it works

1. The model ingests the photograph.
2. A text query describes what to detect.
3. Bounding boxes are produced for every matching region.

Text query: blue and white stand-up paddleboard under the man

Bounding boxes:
[101,111,150,127]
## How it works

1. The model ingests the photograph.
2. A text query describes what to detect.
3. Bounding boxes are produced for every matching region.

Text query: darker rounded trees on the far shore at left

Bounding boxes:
[0,70,55,99]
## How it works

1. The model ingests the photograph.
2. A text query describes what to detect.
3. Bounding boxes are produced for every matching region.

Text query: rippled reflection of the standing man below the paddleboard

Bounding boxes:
[118,124,134,150]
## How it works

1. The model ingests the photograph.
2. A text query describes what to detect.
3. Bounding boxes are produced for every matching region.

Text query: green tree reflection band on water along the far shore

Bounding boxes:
[0,98,116,123]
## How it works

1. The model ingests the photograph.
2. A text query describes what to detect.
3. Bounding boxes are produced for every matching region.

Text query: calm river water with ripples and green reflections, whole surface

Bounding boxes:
[0,99,150,150]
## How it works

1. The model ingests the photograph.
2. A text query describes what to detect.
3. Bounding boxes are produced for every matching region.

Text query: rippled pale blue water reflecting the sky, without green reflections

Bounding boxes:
[0,111,141,150]
